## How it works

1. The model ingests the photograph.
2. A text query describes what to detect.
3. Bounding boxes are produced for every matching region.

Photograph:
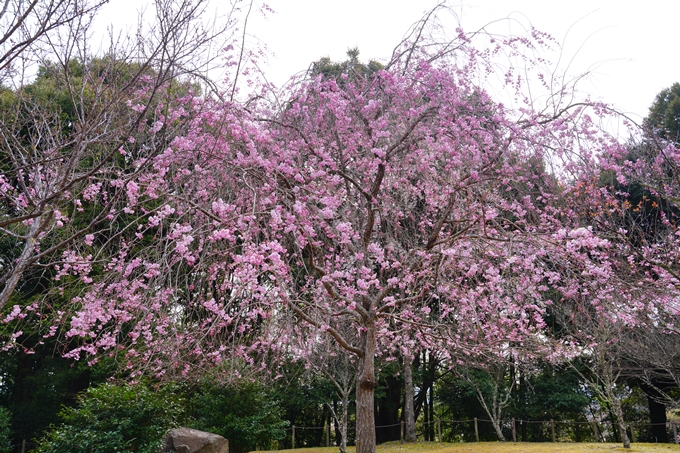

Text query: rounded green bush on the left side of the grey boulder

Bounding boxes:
[35,384,183,453]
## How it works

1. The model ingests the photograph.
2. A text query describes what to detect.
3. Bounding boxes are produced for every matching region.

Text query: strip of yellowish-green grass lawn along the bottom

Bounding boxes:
[258,442,680,453]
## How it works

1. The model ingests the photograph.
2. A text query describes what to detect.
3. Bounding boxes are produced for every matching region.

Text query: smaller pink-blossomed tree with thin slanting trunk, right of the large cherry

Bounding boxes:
[551,174,677,448]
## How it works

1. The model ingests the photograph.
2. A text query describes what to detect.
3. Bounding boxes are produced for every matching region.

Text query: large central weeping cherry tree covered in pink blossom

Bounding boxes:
[8,7,664,453]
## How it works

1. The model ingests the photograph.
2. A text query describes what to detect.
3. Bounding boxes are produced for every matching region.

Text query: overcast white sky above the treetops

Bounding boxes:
[102,0,680,123]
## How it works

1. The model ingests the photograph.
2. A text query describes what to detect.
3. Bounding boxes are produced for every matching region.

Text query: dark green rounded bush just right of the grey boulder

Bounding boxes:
[190,382,288,453]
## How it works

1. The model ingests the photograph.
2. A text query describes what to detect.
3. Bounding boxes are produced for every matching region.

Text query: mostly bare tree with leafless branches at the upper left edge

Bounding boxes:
[0,0,244,309]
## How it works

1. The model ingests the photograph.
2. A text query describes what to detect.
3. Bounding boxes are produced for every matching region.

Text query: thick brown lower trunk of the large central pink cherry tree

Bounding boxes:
[356,320,377,453]
